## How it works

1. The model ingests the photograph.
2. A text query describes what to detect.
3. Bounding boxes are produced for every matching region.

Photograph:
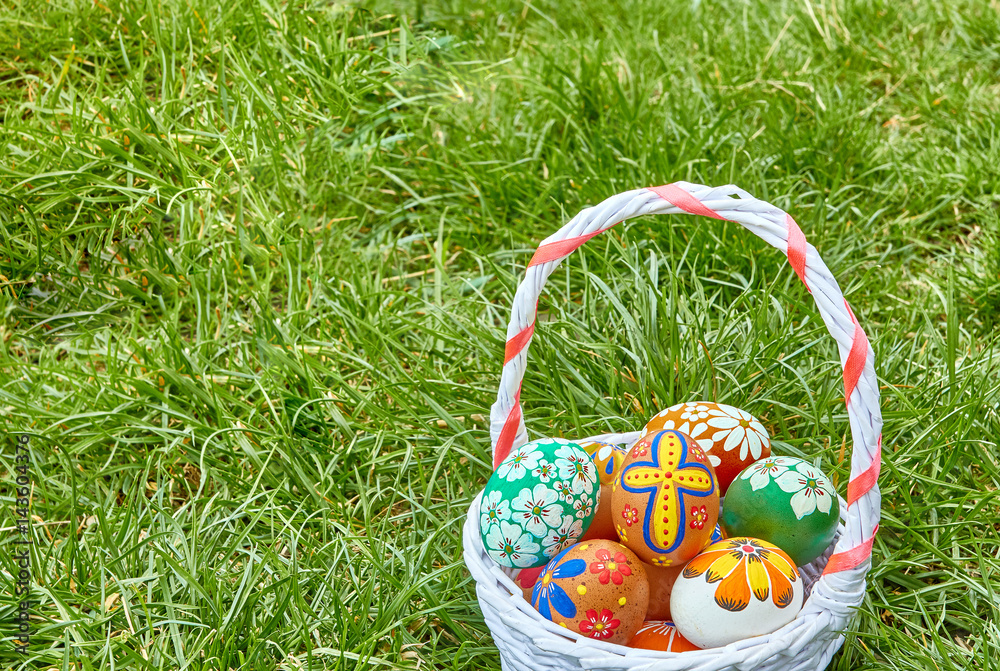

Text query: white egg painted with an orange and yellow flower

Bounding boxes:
[670,538,804,648]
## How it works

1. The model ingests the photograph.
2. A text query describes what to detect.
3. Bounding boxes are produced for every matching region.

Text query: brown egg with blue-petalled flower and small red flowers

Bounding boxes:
[531,540,649,644]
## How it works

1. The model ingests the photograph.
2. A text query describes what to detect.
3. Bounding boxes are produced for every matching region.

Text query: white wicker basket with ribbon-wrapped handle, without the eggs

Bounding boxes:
[463,182,882,671]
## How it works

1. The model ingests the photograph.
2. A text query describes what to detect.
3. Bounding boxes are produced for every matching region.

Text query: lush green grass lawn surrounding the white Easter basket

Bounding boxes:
[0,0,1000,671]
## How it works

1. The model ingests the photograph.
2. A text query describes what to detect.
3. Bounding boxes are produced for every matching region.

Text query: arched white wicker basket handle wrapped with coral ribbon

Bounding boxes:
[490,182,882,573]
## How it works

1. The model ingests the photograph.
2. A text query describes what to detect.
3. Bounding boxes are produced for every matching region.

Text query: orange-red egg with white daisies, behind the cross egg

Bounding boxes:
[642,401,771,496]
